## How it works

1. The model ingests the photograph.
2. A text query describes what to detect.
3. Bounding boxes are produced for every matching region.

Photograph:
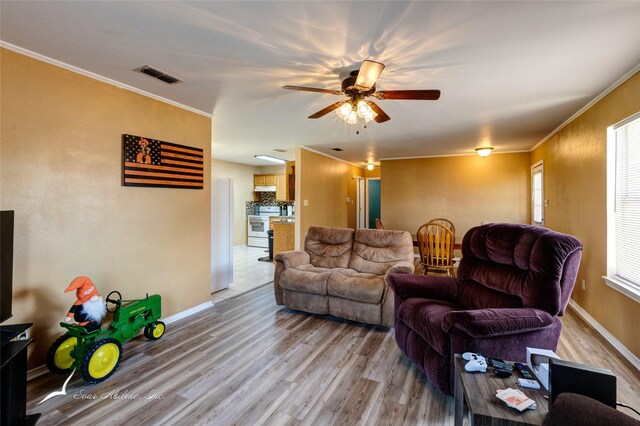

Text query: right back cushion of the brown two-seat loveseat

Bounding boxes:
[349,228,413,275]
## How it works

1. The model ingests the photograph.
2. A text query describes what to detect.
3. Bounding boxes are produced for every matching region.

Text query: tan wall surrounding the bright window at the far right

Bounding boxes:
[531,73,640,357]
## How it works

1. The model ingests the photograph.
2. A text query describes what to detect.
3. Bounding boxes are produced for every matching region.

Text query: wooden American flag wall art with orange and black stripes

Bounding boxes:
[122,135,204,189]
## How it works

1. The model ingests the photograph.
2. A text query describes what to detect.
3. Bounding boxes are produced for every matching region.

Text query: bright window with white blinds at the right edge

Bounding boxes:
[603,112,640,302]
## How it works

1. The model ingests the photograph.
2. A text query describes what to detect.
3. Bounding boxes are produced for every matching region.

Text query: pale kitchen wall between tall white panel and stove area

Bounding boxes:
[211,160,262,246]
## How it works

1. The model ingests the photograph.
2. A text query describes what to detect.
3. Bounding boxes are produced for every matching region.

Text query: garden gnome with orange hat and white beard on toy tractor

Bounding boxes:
[64,277,107,331]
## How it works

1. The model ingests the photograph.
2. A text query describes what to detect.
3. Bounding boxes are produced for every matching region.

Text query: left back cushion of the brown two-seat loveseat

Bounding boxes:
[304,226,354,268]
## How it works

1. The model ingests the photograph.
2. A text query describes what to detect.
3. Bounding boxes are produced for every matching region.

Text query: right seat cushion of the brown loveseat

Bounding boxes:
[327,269,385,303]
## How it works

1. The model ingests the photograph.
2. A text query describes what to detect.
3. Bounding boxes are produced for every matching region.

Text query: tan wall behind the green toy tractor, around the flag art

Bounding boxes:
[0,49,211,367]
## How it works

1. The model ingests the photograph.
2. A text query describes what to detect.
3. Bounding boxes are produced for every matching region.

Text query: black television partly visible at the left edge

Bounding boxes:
[0,210,14,322]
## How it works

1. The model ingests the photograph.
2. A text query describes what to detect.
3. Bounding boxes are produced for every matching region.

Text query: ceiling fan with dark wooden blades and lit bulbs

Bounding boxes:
[283,60,440,124]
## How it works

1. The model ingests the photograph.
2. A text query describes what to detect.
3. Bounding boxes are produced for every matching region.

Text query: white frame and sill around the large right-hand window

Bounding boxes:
[602,113,640,303]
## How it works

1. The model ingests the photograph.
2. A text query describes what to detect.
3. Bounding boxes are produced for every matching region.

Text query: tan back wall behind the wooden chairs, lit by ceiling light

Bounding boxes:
[380,152,531,241]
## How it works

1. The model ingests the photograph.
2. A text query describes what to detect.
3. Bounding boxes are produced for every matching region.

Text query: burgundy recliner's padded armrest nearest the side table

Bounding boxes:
[442,308,554,338]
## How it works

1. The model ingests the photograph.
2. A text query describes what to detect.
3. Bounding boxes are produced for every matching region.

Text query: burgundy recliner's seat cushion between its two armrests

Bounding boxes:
[396,298,462,356]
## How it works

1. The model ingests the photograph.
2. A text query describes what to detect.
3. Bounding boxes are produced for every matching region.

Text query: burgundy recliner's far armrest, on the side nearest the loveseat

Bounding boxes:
[384,274,458,300]
